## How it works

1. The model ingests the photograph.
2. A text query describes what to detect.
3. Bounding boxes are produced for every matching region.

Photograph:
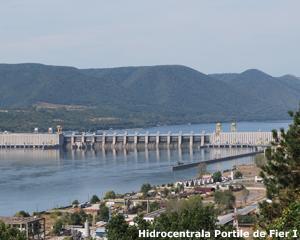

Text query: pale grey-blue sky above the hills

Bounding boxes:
[0,0,300,76]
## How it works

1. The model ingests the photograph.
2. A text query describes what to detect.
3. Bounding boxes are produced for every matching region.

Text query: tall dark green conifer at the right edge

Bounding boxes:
[260,111,300,228]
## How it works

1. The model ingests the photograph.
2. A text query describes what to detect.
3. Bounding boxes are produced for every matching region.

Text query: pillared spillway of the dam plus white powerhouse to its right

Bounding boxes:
[64,132,273,149]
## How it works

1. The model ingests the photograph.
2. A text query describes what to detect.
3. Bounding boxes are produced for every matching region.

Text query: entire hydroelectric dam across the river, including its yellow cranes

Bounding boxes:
[0,123,273,149]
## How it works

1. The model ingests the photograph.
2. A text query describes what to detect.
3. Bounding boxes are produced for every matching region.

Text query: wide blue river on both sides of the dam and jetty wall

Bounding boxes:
[0,121,289,216]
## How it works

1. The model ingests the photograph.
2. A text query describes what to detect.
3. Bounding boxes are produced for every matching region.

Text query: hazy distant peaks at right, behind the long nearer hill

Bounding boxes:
[211,69,300,116]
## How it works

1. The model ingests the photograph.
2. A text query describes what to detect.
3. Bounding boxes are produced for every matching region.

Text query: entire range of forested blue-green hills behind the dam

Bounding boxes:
[0,63,300,129]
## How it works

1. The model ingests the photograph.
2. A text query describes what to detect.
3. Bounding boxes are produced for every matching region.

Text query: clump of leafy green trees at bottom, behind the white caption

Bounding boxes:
[106,196,243,240]
